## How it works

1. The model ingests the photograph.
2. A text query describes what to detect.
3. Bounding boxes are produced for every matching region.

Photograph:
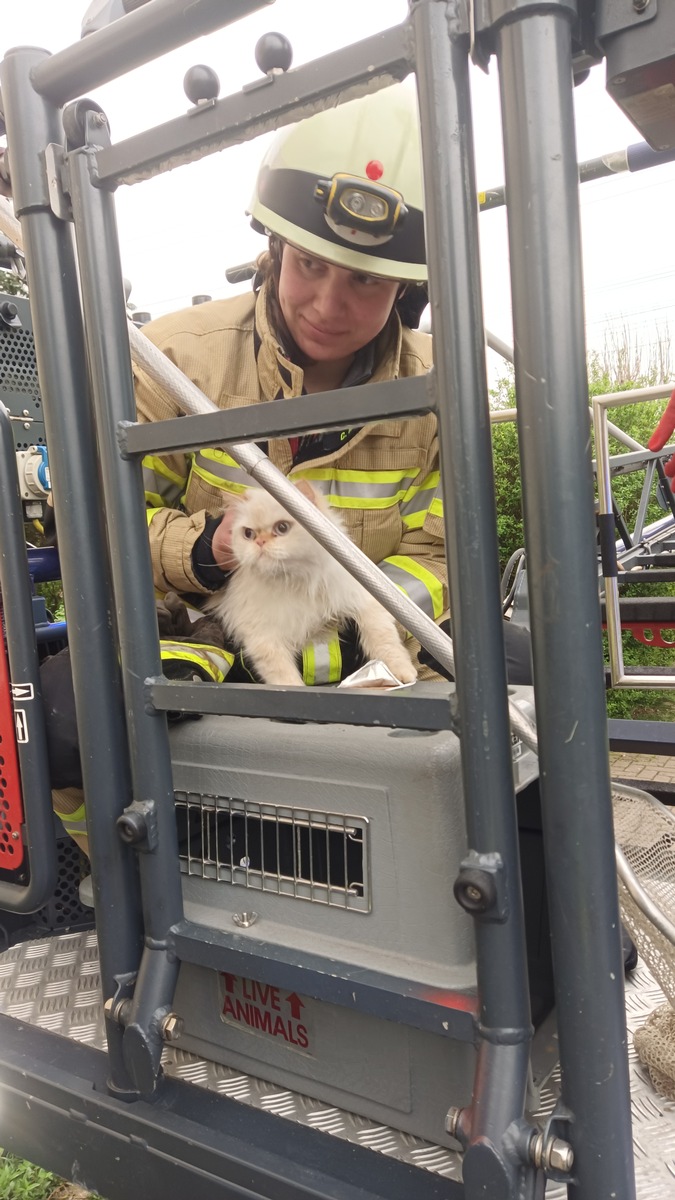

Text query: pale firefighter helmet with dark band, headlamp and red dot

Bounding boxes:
[249,83,426,283]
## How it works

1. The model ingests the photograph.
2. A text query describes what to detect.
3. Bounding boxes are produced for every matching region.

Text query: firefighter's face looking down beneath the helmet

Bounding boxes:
[279,244,400,362]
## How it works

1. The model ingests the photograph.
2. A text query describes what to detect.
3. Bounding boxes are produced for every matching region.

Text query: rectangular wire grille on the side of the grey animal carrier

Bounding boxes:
[175,792,371,912]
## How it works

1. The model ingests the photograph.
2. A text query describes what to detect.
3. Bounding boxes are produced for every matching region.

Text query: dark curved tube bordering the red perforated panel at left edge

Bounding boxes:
[0,404,56,912]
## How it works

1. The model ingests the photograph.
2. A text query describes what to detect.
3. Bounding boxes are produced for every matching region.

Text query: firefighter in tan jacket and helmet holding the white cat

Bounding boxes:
[49,83,530,849]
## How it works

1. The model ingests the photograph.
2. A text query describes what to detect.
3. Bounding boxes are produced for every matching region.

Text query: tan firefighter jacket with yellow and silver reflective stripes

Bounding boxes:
[135,274,448,683]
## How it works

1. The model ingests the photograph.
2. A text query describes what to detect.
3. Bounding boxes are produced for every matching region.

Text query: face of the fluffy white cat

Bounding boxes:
[232,487,322,575]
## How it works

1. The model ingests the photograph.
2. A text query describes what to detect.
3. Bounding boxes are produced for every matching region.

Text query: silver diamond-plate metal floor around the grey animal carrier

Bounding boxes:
[0,931,675,1200]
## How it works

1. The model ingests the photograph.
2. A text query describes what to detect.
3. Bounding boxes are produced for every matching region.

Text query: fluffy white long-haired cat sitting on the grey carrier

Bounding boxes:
[205,480,417,685]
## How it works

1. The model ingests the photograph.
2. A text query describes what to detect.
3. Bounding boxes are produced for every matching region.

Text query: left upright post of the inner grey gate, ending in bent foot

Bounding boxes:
[65,124,183,1092]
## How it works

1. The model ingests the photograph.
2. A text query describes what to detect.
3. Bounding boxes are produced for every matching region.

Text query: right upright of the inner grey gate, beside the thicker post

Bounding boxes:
[411,0,534,1196]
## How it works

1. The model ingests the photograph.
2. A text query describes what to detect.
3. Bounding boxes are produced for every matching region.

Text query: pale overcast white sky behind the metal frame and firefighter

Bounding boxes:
[0,0,675,372]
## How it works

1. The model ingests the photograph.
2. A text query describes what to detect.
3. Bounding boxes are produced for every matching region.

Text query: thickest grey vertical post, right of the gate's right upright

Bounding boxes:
[477,0,635,1200]
